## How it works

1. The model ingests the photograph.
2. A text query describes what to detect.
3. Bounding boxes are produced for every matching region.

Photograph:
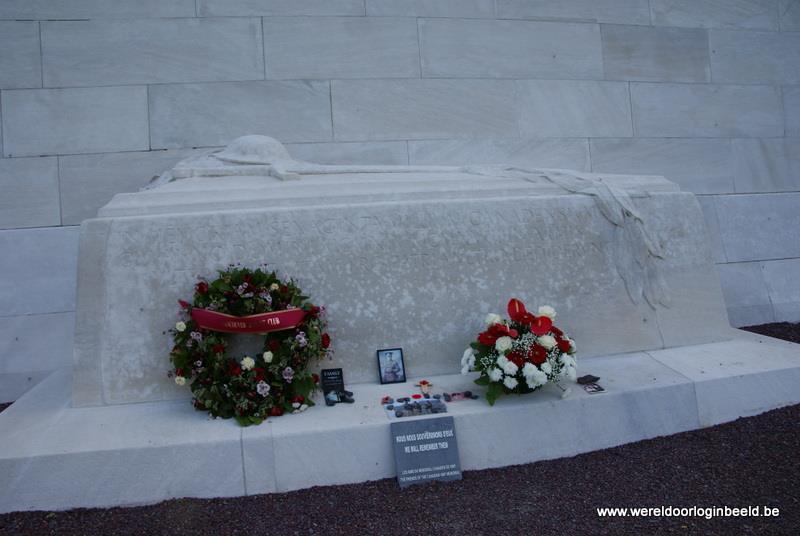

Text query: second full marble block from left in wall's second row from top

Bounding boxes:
[264,17,419,79]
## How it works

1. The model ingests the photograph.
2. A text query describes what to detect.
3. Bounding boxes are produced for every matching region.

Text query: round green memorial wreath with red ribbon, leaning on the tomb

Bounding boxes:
[170,265,331,426]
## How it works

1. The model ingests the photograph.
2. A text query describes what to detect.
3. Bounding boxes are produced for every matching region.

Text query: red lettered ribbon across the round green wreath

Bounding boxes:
[178,300,306,333]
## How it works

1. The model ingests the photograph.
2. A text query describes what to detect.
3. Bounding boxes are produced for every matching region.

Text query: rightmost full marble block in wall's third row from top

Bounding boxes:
[631,82,783,138]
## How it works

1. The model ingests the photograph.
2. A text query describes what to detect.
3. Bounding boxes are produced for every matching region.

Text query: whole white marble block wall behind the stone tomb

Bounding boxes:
[0,0,800,399]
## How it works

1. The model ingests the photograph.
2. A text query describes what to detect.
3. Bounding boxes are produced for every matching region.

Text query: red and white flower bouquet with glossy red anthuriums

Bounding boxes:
[461,299,577,405]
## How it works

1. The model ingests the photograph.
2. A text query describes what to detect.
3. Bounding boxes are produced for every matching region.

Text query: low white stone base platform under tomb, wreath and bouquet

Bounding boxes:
[0,331,800,512]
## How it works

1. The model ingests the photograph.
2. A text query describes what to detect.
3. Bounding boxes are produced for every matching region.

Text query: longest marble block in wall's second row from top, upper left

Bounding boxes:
[42,18,264,87]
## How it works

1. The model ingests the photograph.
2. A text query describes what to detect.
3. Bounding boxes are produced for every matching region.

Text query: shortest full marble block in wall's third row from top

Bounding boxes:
[517,80,633,137]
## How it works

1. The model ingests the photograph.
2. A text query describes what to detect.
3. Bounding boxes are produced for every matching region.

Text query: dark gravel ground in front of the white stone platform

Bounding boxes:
[0,326,800,536]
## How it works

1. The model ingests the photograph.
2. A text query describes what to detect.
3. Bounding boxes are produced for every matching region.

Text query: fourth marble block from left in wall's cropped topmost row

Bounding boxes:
[497,0,650,24]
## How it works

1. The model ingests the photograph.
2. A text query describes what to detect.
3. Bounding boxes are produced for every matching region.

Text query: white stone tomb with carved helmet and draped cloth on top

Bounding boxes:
[73,136,729,406]
